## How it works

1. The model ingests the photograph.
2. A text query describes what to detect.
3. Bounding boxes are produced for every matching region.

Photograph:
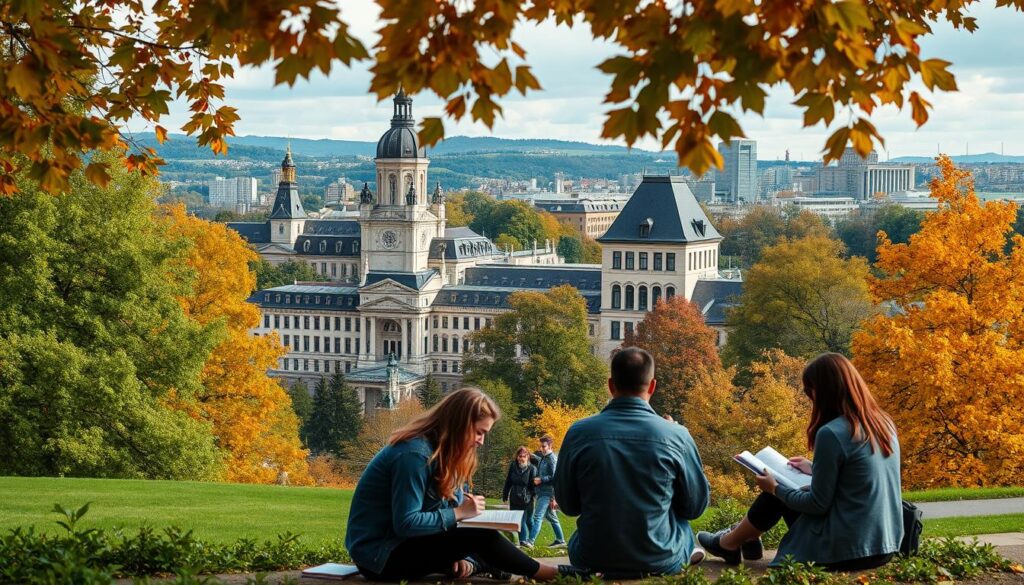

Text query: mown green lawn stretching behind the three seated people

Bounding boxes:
[0,477,1024,544]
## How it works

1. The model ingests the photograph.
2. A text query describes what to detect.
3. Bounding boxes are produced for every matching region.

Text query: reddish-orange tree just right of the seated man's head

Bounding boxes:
[624,296,722,420]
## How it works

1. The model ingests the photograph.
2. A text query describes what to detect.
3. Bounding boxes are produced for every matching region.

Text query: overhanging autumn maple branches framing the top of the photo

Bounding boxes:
[0,0,1011,193]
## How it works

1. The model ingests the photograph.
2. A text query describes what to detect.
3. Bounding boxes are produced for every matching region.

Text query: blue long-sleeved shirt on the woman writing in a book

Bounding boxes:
[345,437,462,573]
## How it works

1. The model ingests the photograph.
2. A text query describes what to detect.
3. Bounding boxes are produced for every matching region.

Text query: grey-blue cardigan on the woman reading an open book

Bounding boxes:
[772,416,903,566]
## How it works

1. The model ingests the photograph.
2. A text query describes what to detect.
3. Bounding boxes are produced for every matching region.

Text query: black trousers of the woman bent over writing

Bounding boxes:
[359,528,541,581]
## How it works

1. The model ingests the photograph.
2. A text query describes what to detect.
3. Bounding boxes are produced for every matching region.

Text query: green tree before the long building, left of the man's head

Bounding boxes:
[465,285,608,411]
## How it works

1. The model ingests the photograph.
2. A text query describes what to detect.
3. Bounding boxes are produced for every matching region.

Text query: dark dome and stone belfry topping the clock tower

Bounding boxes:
[377,89,430,207]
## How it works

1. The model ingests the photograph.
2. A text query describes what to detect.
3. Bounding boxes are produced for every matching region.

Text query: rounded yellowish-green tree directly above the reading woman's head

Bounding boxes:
[725,236,874,366]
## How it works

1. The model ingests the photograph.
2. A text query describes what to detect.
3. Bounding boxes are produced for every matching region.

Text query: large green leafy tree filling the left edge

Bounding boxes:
[0,154,222,479]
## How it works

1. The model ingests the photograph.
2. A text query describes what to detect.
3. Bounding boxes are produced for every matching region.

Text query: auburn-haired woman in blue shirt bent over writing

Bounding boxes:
[345,388,560,581]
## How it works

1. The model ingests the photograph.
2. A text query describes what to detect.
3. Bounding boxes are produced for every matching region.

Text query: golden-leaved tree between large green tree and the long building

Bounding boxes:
[160,206,309,484]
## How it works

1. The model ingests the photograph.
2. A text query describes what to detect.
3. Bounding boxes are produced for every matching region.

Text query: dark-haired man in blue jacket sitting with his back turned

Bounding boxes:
[555,347,710,579]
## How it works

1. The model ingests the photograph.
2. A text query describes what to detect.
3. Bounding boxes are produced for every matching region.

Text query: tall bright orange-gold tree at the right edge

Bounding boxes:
[853,157,1024,487]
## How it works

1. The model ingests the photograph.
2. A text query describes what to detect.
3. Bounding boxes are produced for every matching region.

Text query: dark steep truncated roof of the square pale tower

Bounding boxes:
[597,175,722,244]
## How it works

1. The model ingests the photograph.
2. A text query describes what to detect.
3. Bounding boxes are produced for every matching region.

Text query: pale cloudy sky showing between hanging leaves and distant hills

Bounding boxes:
[149,0,1024,160]
